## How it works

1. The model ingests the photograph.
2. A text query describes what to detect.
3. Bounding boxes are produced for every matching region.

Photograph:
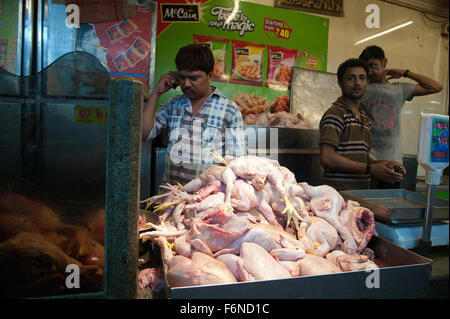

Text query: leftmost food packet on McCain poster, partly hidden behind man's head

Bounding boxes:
[193,34,229,82]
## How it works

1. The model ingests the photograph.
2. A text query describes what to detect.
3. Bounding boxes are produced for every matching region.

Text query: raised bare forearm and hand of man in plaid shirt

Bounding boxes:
[142,72,176,141]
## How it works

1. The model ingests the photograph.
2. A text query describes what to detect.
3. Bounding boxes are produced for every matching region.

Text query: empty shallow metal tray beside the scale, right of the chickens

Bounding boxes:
[340,189,448,224]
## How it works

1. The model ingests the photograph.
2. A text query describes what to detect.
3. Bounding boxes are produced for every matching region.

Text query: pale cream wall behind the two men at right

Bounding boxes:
[246,0,449,176]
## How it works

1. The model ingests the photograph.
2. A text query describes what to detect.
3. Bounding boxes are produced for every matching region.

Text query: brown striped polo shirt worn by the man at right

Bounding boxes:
[319,97,372,188]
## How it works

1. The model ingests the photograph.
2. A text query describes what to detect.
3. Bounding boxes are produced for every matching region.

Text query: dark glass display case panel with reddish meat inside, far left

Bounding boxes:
[0,53,110,298]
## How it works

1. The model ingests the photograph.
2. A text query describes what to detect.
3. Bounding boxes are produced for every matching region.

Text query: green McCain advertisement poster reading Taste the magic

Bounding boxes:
[155,0,329,116]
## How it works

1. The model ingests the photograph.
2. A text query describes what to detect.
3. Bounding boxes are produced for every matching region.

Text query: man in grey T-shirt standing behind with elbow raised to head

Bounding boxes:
[359,45,442,188]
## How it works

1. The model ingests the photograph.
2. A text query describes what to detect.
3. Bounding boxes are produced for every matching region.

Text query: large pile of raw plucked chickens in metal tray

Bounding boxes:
[138,155,377,290]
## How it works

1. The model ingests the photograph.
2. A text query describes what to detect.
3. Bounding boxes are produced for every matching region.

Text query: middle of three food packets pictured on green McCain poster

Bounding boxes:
[230,40,265,86]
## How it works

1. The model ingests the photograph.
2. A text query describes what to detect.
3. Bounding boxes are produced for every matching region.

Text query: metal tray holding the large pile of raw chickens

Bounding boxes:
[160,236,432,299]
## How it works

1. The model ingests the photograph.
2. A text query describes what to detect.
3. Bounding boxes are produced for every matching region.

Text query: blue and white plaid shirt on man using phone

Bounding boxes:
[147,87,246,185]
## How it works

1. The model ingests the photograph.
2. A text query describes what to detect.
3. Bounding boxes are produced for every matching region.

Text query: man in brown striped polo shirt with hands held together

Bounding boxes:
[319,59,403,190]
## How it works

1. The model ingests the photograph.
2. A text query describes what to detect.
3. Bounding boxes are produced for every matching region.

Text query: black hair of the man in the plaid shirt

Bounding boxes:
[175,43,214,74]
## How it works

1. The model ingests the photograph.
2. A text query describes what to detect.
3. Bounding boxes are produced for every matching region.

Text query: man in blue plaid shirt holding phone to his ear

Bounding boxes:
[142,44,246,185]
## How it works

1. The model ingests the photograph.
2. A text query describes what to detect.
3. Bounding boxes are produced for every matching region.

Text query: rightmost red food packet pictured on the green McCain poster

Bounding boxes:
[266,45,297,90]
